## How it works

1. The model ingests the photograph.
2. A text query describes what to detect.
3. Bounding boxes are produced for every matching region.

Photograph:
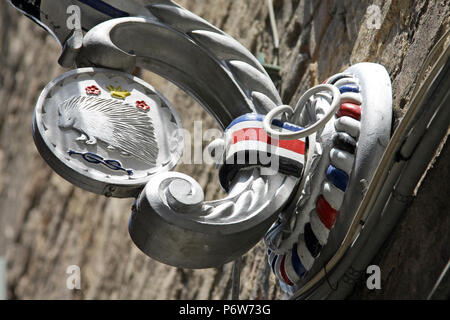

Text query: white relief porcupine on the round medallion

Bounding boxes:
[58,96,158,166]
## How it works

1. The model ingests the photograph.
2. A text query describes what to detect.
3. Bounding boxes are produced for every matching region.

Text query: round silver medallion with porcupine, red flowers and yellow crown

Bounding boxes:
[33,68,184,197]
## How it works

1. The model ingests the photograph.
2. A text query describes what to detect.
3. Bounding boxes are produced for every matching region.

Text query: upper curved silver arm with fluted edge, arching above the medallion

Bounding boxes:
[78,14,281,128]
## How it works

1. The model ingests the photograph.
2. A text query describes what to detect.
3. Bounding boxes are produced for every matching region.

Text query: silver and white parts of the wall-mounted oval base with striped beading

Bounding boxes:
[266,63,392,293]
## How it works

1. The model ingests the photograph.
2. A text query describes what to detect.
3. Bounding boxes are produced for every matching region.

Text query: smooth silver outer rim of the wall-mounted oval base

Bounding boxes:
[299,63,392,286]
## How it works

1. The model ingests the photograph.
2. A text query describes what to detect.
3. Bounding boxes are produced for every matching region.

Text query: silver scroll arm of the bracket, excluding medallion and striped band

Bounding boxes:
[13,0,298,268]
